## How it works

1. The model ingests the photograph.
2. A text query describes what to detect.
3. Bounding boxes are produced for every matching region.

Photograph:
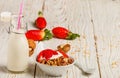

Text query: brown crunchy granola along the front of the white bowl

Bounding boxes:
[40,56,74,66]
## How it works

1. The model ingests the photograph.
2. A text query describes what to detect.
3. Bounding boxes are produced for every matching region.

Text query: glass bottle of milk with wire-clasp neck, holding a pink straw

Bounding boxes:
[7,16,29,72]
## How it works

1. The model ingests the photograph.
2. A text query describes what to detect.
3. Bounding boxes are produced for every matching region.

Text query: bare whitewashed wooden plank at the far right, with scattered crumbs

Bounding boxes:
[89,0,120,78]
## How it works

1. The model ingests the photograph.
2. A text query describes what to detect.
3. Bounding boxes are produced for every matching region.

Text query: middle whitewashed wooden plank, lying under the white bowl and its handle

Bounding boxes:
[36,0,99,78]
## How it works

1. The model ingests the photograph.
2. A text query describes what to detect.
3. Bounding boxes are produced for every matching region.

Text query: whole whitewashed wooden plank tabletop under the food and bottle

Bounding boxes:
[0,0,120,78]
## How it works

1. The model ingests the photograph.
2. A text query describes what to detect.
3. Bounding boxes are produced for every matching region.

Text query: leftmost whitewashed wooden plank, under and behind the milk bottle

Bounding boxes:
[0,0,42,78]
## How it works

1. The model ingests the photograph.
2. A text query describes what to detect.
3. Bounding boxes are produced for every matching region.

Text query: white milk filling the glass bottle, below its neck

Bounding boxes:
[7,33,29,72]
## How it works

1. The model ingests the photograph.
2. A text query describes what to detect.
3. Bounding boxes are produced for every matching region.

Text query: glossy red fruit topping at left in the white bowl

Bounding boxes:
[37,49,58,62]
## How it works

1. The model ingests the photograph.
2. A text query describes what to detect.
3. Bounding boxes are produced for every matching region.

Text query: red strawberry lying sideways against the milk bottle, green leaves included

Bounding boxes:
[25,29,52,41]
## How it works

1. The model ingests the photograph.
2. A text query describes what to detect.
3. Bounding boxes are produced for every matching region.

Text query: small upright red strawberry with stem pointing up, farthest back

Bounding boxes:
[35,12,47,29]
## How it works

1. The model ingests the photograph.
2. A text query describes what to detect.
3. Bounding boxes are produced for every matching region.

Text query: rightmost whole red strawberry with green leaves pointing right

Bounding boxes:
[52,27,80,40]
